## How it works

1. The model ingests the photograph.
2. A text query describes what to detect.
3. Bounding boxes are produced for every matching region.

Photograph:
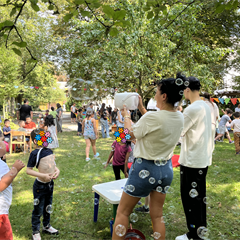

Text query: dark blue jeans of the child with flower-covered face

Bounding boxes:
[32,179,54,233]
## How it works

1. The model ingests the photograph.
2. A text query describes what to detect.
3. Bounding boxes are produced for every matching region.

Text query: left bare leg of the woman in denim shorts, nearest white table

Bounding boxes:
[112,192,140,240]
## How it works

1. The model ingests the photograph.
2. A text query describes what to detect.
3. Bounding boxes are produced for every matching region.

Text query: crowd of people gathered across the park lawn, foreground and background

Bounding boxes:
[0,77,240,240]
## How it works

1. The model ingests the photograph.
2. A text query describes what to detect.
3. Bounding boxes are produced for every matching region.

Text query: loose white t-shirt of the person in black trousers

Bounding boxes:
[179,100,214,168]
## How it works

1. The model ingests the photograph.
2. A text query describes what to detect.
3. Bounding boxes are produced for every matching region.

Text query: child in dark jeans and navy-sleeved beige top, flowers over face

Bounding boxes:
[27,129,60,240]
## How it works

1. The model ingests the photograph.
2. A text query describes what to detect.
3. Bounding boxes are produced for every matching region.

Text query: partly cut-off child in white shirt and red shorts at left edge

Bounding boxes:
[0,142,24,240]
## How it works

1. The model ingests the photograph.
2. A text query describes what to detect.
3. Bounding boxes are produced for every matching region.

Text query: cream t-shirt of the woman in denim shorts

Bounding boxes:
[133,110,183,160]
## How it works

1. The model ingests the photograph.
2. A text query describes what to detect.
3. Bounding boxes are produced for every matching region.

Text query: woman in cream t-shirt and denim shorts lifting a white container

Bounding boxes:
[112,74,186,240]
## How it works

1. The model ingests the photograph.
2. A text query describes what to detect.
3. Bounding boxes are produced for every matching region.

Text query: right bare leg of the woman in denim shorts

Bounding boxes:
[150,191,166,240]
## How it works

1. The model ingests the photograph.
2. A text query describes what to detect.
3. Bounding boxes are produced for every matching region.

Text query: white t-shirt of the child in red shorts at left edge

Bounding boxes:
[0,160,12,215]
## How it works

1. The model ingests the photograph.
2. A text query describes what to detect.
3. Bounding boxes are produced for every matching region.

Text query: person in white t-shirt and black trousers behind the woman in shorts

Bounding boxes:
[176,77,214,240]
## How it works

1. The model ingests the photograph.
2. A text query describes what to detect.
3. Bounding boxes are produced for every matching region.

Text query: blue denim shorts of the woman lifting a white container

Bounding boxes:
[124,158,173,198]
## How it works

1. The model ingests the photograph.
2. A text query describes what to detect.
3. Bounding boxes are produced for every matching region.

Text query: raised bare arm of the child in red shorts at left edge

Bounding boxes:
[0,160,25,192]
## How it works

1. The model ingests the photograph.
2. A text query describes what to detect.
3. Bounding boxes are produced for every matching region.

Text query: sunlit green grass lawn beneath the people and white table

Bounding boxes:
[7,132,240,240]
